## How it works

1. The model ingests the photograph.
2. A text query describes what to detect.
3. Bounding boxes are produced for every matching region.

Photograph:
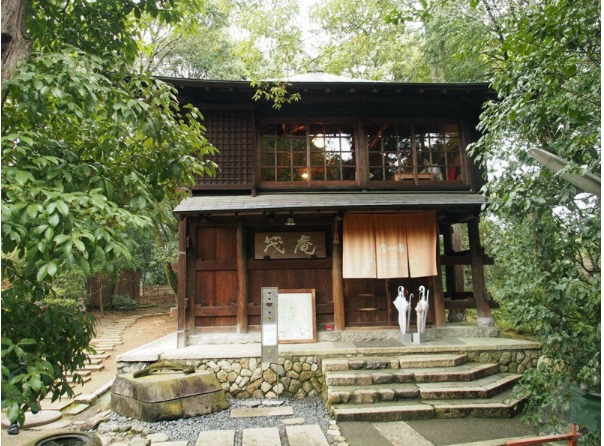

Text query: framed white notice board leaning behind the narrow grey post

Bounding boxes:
[277,289,317,344]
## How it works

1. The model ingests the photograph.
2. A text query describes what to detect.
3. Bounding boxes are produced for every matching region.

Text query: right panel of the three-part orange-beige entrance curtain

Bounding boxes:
[405,212,437,277]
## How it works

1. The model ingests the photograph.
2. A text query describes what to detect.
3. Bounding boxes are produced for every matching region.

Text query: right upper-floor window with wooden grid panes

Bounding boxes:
[367,124,463,184]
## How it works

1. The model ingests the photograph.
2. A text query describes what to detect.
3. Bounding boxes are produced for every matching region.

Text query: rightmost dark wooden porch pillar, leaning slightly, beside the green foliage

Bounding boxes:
[468,217,495,327]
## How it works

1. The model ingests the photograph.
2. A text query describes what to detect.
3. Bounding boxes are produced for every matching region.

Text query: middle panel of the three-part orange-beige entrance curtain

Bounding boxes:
[373,214,409,279]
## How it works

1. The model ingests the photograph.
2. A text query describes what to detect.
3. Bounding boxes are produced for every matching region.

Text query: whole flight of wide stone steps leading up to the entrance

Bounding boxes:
[322,353,523,421]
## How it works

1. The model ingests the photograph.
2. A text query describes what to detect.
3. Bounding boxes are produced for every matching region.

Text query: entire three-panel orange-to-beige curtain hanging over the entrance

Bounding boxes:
[342,212,437,279]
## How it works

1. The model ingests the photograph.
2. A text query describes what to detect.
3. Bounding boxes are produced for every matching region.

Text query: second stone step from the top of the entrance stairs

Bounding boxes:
[325,362,498,386]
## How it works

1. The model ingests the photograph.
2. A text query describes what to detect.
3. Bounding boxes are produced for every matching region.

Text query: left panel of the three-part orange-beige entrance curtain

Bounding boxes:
[342,214,376,279]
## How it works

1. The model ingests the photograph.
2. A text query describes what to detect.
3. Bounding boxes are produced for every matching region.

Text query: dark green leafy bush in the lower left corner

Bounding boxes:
[2,286,94,423]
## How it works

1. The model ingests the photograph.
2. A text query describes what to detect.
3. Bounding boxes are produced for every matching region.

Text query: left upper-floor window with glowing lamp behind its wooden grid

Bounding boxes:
[260,123,356,182]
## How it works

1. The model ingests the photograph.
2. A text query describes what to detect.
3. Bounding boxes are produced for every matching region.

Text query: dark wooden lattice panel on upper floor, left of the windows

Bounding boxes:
[193,110,254,189]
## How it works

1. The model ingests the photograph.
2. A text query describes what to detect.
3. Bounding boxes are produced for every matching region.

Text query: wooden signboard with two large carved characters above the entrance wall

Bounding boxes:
[254,232,326,259]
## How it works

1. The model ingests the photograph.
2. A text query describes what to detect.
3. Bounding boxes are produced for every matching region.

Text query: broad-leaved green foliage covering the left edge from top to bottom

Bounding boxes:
[1,0,216,422]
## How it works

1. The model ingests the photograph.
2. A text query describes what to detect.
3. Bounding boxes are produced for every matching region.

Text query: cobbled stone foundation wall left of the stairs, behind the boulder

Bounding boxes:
[117,356,325,398]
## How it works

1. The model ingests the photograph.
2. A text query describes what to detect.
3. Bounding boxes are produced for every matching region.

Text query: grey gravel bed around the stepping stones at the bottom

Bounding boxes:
[108,398,336,446]
